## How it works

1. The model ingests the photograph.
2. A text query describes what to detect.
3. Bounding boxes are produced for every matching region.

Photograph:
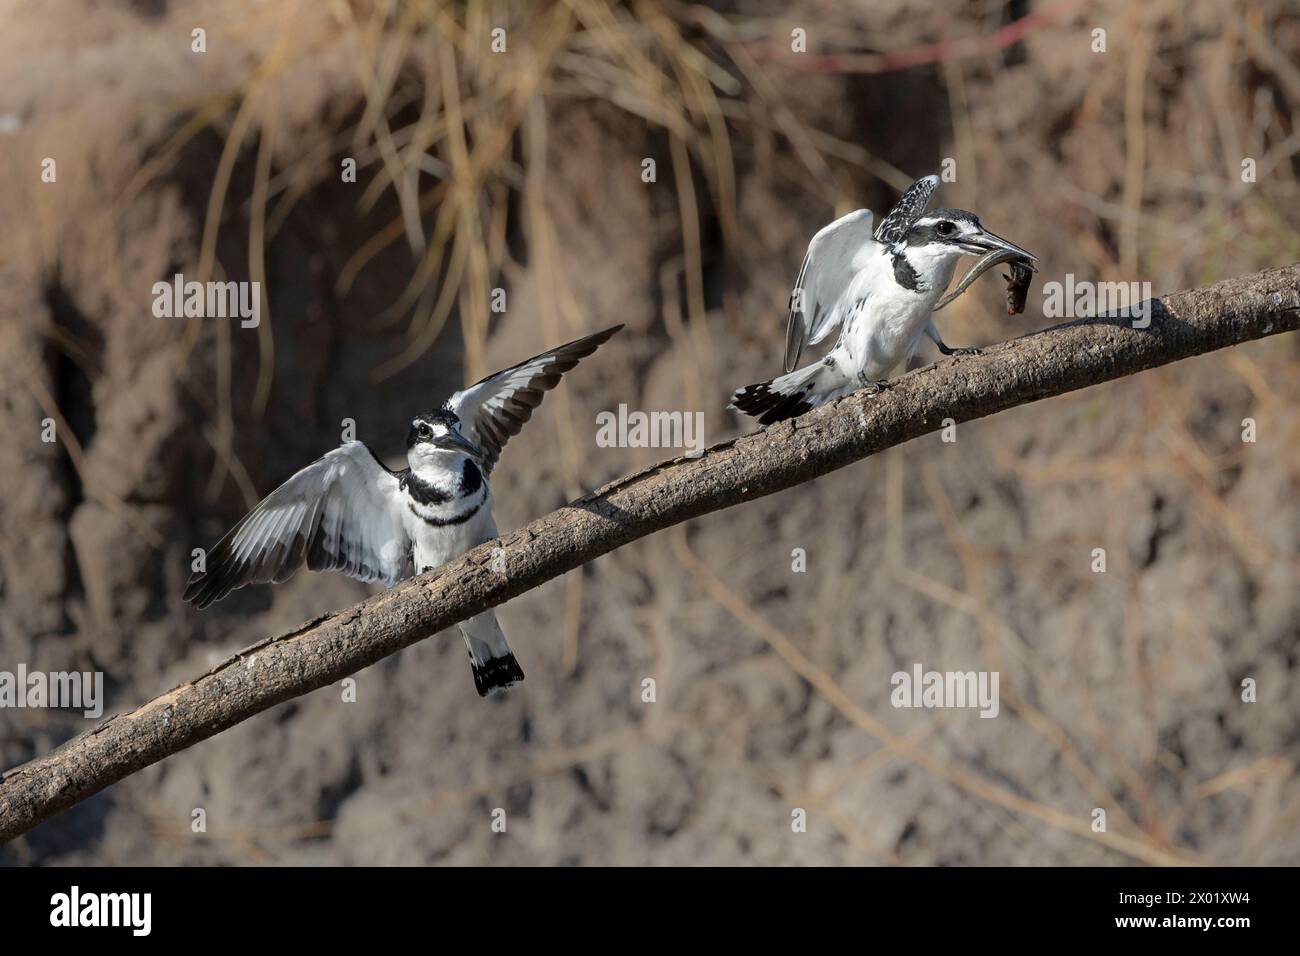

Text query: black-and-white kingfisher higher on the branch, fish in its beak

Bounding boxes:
[729,176,1035,425]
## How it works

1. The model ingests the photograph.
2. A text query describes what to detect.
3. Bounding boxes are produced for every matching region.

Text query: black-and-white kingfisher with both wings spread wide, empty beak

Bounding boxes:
[185,325,623,696]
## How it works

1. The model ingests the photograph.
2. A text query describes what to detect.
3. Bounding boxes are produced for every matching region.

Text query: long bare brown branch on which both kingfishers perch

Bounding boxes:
[0,264,1300,842]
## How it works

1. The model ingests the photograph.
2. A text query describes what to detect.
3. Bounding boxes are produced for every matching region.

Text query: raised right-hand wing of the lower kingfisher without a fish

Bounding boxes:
[445,325,623,473]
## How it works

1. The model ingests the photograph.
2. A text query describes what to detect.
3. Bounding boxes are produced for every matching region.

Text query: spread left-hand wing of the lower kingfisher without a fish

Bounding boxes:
[185,441,411,607]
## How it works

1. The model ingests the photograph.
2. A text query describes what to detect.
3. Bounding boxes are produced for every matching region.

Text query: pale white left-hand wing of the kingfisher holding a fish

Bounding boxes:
[785,209,875,372]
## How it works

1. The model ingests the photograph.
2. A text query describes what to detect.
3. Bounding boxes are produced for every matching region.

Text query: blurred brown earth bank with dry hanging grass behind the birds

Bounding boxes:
[0,0,1300,865]
